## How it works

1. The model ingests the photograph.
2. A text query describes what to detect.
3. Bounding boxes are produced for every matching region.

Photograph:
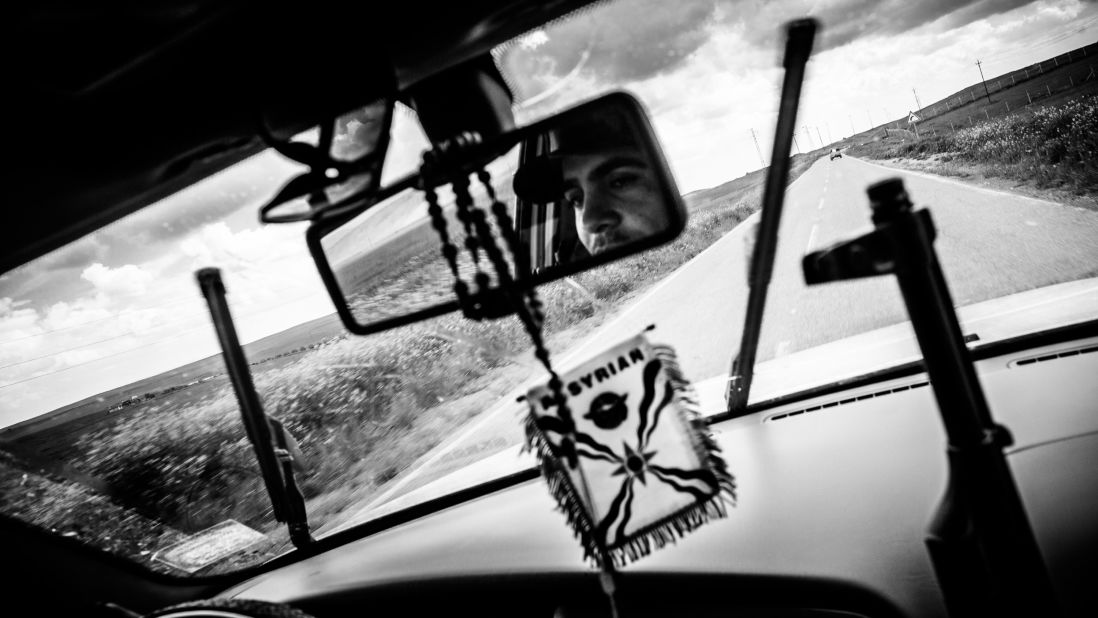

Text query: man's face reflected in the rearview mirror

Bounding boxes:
[561,148,669,256]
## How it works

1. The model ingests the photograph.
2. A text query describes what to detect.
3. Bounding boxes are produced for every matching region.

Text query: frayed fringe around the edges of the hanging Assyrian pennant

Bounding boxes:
[524,345,737,569]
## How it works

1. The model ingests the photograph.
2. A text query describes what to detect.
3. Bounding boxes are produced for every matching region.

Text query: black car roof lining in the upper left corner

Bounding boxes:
[0,0,590,272]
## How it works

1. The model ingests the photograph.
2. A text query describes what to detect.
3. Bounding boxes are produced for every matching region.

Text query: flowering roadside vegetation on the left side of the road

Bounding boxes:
[0,151,822,573]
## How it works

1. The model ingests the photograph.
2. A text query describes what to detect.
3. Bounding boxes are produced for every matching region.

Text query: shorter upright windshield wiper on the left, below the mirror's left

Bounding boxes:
[195,268,314,548]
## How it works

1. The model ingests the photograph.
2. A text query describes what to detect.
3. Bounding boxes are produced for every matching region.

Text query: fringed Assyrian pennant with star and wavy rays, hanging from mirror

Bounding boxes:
[526,335,736,568]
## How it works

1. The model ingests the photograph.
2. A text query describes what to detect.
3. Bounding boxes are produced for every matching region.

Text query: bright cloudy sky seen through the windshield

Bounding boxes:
[0,0,1098,427]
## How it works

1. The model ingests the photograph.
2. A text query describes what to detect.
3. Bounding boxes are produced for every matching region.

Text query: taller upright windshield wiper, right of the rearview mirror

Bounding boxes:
[725,19,818,418]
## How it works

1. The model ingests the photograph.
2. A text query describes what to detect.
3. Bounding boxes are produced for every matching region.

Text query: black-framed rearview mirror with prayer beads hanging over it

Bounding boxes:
[306,93,686,335]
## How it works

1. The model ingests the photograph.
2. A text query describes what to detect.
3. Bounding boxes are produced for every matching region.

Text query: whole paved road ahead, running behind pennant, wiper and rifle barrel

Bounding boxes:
[346,157,1098,516]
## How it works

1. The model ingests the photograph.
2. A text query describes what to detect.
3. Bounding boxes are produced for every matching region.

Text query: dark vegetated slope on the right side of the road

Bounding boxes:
[852,94,1098,196]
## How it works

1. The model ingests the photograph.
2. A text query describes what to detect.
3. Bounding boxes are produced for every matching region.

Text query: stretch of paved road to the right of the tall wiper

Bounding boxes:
[759,157,1098,361]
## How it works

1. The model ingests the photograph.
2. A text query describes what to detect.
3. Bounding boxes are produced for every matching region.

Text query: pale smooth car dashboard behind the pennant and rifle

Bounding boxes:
[220,337,1098,618]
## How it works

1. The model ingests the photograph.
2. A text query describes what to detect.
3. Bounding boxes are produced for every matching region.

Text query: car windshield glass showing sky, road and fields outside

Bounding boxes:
[0,0,1098,575]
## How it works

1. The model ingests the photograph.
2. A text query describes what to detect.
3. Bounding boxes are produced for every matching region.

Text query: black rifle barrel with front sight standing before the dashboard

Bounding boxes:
[803,178,1061,617]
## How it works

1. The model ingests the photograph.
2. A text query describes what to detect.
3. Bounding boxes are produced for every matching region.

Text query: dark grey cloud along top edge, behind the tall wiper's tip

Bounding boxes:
[500,0,1033,101]
